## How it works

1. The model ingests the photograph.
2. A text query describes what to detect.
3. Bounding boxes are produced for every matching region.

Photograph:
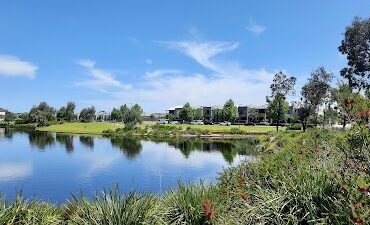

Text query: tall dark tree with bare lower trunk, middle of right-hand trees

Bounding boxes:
[301,67,333,126]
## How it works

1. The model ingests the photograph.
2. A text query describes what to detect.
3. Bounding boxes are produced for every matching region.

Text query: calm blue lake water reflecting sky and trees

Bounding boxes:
[0,128,255,202]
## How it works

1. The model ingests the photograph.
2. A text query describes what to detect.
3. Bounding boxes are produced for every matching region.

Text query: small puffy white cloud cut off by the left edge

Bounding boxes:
[0,55,38,79]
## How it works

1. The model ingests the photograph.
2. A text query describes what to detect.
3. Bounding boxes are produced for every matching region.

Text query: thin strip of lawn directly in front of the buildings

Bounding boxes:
[165,124,285,132]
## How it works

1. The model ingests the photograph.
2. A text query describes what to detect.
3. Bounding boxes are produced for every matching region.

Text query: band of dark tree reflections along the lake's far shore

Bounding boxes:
[0,128,254,164]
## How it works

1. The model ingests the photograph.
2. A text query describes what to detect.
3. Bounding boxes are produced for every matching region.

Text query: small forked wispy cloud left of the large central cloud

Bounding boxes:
[75,59,131,92]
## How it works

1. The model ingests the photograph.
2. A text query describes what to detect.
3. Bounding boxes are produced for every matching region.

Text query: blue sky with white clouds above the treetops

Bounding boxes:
[0,0,370,112]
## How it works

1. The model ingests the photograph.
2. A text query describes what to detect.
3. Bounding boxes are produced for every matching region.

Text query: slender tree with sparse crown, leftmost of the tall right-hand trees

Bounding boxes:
[266,72,296,131]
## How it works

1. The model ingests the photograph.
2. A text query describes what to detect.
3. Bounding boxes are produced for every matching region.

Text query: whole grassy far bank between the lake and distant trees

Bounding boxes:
[36,122,284,138]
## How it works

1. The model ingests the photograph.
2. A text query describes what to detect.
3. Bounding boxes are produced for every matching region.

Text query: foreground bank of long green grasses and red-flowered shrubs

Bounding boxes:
[0,127,370,225]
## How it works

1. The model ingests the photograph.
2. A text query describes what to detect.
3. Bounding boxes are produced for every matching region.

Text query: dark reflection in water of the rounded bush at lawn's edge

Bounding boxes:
[110,137,143,160]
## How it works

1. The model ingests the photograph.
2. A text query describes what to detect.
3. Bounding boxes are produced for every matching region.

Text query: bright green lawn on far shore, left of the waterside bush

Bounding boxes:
[37,122,123,134]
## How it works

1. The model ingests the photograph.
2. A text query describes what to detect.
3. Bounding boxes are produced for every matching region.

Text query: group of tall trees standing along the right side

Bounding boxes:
[267,17,370,131]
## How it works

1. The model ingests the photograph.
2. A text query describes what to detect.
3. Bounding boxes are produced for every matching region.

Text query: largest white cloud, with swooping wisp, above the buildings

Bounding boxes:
[76,36,276,112]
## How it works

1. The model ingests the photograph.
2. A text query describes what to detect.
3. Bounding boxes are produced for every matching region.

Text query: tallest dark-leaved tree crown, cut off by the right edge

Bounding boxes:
[338,17,370,90]
